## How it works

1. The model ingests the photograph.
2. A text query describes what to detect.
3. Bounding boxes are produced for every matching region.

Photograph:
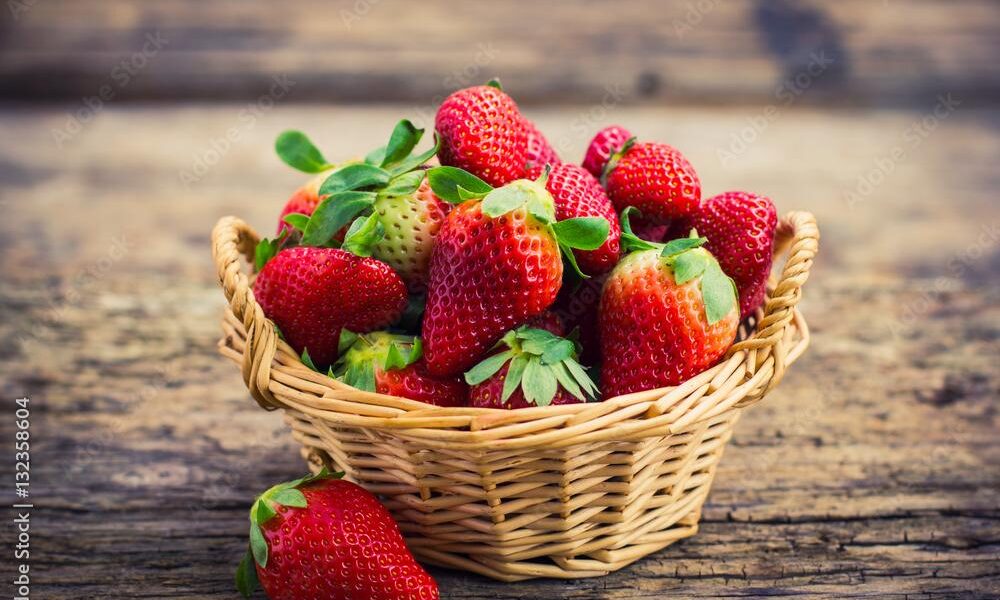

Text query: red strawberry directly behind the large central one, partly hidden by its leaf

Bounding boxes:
[529,163,621,275]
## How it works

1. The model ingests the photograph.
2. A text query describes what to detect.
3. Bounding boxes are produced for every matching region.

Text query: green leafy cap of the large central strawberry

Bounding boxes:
[427,167,611,278]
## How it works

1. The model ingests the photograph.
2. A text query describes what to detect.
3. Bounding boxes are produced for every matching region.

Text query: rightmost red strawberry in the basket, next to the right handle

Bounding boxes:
[686,192,778,318]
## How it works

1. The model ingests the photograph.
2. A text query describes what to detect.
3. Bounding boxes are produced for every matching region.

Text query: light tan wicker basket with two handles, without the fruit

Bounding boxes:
[212,212,819,581]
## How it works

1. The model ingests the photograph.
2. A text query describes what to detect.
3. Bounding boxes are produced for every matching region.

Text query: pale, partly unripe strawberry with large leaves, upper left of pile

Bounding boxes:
[275,119,451,292]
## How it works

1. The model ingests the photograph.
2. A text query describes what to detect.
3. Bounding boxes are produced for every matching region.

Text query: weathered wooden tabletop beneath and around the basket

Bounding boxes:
[0,103,1000,600]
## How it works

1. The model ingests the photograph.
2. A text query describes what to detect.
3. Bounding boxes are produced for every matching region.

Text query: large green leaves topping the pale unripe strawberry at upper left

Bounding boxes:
[254,119,440,271]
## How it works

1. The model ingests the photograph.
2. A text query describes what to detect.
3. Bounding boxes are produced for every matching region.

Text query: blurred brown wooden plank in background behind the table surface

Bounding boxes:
[0,0,1000,105]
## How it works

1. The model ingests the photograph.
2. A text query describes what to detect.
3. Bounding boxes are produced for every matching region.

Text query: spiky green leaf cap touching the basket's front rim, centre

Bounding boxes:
[465,325,599,406]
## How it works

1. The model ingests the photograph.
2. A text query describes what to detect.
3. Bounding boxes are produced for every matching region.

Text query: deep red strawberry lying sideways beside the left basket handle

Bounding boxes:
[253,247,406,369]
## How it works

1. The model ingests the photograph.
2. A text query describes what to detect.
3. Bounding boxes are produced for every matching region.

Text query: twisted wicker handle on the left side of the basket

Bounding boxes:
[212,217,279,410]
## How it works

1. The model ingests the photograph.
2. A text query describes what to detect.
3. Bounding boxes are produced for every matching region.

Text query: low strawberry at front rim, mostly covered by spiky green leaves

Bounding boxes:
[465,326,598,408]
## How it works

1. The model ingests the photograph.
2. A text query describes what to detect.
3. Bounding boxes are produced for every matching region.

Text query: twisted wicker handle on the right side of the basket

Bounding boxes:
[728,212,819,406]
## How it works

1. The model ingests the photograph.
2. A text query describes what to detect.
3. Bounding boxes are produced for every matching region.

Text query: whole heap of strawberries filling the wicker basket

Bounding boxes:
[254,82,777,409]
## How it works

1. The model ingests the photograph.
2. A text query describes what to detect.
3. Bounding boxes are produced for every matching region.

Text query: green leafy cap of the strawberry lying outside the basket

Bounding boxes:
[236,467,344,598]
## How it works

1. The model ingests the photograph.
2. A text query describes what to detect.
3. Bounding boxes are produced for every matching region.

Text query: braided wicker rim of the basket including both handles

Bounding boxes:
[212,212,819,451]
